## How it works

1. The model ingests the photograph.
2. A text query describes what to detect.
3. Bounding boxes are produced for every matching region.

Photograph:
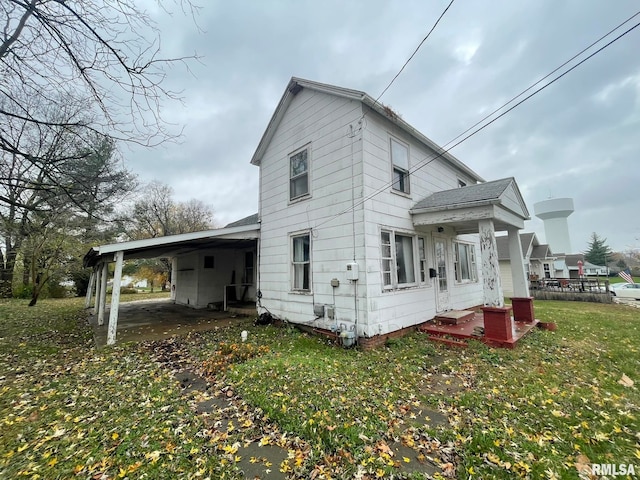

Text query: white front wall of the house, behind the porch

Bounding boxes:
[363,109,482,335]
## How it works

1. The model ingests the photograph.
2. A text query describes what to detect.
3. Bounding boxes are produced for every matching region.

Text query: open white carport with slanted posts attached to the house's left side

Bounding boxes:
[84,221,260,345]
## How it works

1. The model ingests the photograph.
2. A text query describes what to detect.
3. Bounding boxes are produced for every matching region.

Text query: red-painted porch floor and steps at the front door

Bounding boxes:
[420,312,540,348]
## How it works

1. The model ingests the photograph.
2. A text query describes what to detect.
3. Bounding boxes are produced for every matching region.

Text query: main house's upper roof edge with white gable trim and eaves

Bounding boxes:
[251,77,484,182]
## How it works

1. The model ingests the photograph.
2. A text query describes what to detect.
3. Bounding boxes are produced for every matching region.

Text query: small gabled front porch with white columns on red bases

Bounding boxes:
[410,178,537,345]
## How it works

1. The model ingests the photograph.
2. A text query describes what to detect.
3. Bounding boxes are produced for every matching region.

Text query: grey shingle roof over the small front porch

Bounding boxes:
[412,177,515,210]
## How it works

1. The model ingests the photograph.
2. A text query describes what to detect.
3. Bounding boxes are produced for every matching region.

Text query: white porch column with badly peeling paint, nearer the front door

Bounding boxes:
[478,219,504,307]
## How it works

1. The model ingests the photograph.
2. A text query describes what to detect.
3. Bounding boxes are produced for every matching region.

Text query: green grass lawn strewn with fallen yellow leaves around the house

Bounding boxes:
[0,296,640,479]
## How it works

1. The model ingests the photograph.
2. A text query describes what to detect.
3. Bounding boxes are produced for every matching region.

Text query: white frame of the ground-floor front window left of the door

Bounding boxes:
[379,228,420,291]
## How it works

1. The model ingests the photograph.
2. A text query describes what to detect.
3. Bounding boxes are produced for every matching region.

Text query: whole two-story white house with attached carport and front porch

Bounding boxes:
[86,78,529,341]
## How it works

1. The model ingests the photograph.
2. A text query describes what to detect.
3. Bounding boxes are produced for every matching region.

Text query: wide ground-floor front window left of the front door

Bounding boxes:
[380,230,416,290]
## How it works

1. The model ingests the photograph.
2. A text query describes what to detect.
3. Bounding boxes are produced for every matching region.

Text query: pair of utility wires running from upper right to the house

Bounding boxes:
[314,12,640,228]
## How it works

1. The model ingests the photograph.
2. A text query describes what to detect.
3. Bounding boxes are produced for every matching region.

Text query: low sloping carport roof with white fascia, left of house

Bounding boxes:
[84,223,260,267]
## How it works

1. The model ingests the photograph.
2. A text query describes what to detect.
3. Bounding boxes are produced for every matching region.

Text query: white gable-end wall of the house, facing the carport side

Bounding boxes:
[259,89,366,328]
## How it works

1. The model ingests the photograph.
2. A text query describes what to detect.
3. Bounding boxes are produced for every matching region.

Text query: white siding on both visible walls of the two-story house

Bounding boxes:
[259,88,483,336]
